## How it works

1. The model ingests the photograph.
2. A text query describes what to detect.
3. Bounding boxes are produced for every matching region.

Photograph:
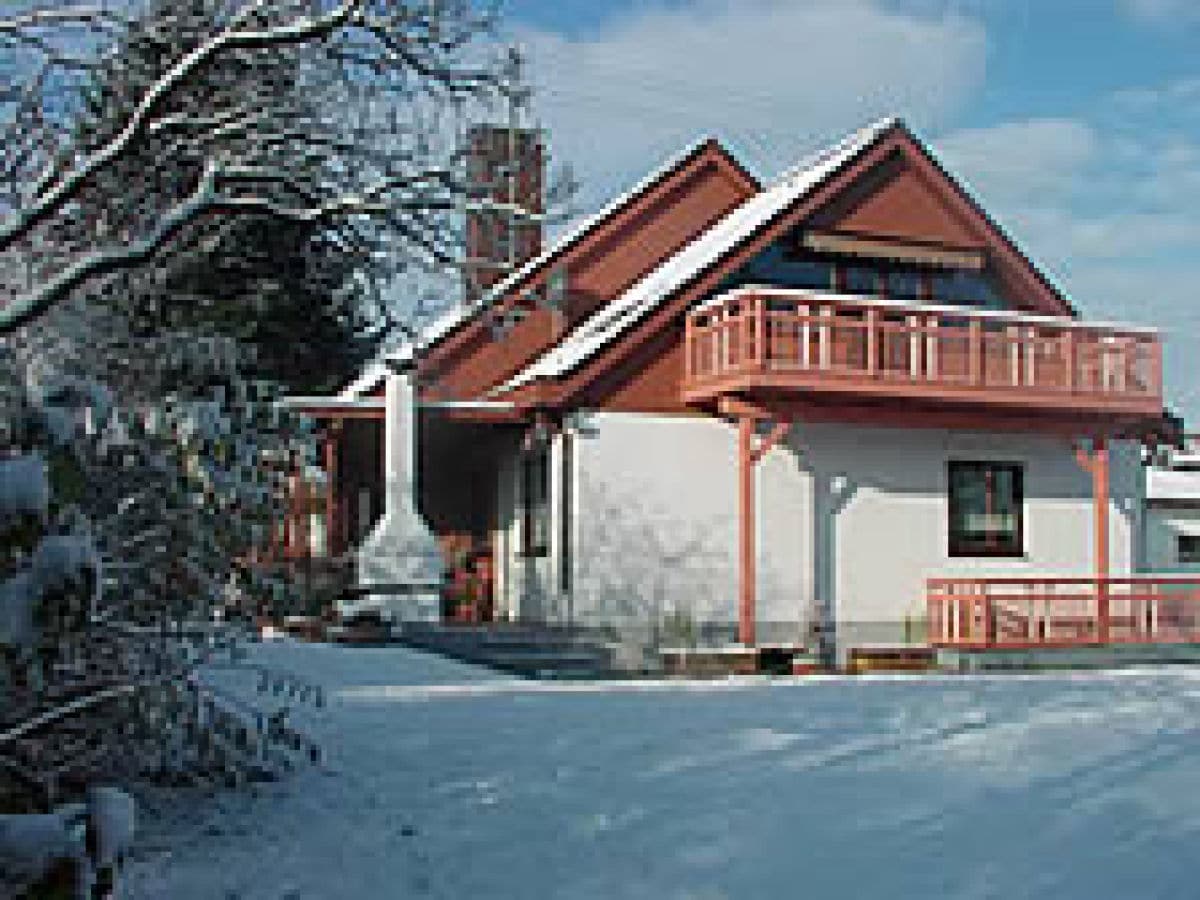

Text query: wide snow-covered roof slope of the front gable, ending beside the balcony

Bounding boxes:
[497,118,899,392]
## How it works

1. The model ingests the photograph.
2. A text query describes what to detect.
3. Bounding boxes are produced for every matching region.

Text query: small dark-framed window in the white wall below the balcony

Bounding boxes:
[949,462,1025,557]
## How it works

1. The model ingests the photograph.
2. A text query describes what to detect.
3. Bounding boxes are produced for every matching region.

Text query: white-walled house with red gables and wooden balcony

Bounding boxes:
[283,119,1181,659]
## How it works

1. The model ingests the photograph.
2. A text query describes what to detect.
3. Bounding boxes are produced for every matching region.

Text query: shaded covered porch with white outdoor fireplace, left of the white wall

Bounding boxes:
[278,388,528,623]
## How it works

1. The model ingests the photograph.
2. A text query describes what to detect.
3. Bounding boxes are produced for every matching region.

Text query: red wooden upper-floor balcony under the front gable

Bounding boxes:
[683,287,1163,415]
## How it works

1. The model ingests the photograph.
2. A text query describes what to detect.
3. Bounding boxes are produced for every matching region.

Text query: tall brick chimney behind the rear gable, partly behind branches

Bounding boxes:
[463,125,545,304]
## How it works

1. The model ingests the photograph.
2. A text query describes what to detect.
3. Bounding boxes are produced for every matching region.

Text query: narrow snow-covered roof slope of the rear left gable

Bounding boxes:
[338,137,729,398]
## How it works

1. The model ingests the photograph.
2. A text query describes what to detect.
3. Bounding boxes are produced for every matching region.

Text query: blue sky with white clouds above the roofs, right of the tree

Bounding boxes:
[506,0,1200,422]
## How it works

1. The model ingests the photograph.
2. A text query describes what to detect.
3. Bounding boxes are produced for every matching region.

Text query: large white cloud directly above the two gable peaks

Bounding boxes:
[518,0,986,203]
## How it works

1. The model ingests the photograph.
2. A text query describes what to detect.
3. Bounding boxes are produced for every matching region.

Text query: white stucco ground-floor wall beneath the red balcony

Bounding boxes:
[556,413,1141,642]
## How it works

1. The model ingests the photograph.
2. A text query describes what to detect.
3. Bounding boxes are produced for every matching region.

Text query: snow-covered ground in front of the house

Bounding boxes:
[127,643,1200,900]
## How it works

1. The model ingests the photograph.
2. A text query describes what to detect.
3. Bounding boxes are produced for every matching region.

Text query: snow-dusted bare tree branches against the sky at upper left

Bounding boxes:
[0,0,561,334]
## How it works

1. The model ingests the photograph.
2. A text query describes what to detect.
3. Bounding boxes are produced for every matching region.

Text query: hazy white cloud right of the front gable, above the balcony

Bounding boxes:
[934,99,1200,419]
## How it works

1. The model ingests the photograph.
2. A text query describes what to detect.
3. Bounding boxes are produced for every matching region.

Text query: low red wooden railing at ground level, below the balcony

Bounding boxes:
[926,576,1200,649]
